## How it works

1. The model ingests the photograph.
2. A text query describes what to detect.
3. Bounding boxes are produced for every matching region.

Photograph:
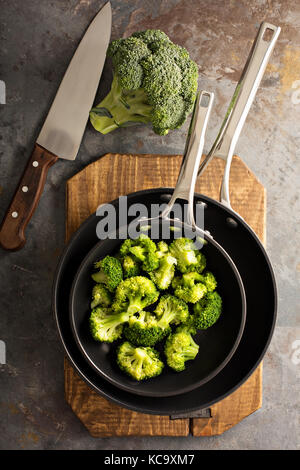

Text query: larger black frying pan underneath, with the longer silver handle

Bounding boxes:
[53,23,279,415]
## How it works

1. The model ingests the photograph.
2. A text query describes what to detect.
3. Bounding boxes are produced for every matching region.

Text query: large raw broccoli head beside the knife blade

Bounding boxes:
[90,30,198,135]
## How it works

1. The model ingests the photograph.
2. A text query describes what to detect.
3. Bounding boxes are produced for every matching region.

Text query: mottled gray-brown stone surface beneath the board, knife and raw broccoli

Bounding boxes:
[0,0,300,449]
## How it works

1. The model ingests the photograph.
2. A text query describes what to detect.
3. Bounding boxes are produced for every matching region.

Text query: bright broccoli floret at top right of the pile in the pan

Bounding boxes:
[169,237,206,273]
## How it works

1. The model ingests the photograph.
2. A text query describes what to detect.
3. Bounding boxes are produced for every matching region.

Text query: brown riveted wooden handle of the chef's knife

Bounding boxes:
[0,144,58,251]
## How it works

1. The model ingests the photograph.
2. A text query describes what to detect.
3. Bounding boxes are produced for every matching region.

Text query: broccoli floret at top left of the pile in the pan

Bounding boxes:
[119,234,159,272]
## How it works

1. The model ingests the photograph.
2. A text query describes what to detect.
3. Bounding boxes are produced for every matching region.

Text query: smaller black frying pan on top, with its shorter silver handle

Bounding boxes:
[70,91,246,397]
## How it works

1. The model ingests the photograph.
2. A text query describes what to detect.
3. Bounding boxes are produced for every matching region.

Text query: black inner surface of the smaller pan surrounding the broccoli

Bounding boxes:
[70,223,246,397]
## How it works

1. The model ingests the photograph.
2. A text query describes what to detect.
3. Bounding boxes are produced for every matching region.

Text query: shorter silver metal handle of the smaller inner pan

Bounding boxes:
[161,90,214,226]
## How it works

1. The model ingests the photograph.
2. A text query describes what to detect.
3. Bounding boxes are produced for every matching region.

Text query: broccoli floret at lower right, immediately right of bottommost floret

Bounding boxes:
[164,325,199,372]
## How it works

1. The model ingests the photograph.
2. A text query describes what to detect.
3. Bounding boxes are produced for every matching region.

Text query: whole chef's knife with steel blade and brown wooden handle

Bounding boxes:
[0,2,112,250]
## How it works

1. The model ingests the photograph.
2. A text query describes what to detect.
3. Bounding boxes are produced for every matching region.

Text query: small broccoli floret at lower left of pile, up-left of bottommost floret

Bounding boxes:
[90,307,129,343]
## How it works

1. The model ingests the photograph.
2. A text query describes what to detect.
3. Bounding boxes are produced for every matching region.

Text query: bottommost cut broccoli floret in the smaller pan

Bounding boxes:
[117,341,164,381]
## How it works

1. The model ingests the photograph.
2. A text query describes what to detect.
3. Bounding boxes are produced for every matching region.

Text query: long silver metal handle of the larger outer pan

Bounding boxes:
[198,22,281,208]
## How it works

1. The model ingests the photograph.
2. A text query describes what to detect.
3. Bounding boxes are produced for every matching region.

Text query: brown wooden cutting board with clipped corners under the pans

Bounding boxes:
[65,154,266,437]
